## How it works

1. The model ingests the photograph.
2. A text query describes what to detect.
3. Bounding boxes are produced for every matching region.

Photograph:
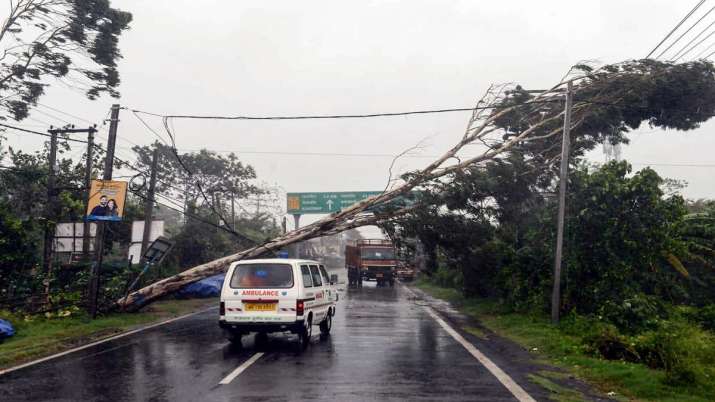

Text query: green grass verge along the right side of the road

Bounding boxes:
[415,280,714,402]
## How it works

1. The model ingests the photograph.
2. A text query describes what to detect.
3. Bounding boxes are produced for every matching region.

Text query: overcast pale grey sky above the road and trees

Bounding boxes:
[2,0,715,228]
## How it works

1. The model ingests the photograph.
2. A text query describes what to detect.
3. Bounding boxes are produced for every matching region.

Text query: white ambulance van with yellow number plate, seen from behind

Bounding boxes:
[219,258,338,347]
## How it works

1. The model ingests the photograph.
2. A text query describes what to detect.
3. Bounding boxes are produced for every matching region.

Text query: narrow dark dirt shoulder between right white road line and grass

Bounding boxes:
[408,285,617,402]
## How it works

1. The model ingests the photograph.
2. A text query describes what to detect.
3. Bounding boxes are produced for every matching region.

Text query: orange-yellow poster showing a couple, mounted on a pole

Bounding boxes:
[87,180,127,221]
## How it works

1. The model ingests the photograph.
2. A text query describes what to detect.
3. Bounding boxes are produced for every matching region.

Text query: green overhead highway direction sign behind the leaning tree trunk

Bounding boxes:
[288,191,382,215]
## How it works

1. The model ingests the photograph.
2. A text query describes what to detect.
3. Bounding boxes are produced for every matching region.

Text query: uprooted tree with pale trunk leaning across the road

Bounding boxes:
[116,60,715,311]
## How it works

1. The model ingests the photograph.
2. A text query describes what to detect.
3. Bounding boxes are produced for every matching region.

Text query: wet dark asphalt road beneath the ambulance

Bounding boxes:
[0,283,515,402]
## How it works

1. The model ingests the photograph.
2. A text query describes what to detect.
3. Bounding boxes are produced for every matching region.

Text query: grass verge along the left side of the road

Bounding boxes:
[0,299,217,369]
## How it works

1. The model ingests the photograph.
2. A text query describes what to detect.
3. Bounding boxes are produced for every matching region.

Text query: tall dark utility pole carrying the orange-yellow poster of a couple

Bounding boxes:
[89,104,119,318]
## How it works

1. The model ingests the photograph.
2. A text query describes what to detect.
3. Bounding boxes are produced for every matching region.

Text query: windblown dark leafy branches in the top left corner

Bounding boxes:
[0,0,132,120]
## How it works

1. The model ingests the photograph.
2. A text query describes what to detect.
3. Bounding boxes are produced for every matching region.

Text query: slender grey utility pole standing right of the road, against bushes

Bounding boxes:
[551,81,573,324]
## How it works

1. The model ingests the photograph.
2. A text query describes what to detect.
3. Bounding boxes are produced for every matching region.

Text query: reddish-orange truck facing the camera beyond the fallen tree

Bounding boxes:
[345,239,397,287]
